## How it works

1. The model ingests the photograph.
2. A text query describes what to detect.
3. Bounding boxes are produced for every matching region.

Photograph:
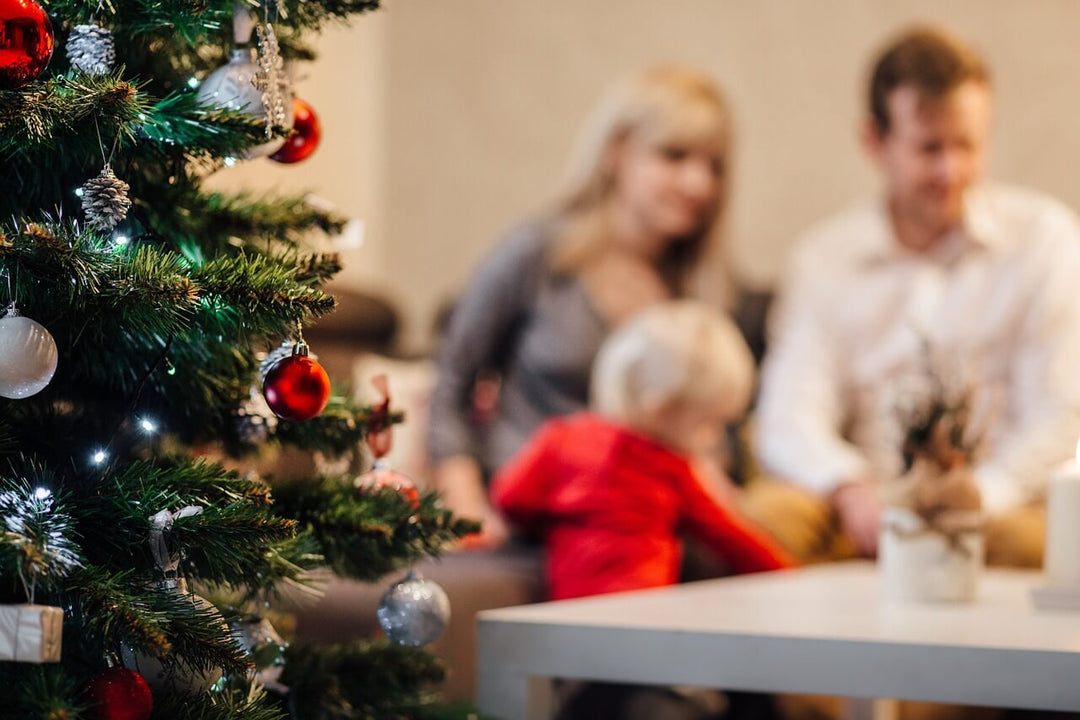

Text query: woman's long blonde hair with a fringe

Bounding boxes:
[551,67,730,296]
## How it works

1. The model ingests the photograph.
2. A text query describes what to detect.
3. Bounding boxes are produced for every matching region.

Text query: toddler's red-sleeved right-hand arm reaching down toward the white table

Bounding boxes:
[683,473,797,572]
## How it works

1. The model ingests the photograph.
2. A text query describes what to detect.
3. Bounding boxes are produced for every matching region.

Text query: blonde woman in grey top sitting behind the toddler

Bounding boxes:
[429,68,730,547]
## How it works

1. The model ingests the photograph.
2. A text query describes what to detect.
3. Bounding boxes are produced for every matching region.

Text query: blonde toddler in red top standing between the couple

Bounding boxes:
[491,300,793,599]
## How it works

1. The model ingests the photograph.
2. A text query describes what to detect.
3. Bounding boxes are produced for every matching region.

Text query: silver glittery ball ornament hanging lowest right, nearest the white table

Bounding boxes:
[376,572,450,648]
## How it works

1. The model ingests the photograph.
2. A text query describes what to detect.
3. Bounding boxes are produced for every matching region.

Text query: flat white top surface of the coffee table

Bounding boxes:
[480,562,1080,652]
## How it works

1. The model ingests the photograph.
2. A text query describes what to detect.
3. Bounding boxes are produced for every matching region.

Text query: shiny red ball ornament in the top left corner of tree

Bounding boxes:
[0,0,53,90]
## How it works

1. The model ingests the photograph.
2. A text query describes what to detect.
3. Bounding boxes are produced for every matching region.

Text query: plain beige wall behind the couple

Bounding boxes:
[214,0,1080,347]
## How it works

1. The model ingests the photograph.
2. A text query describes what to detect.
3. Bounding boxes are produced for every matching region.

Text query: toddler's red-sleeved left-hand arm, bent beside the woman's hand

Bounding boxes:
[491,422,561,527]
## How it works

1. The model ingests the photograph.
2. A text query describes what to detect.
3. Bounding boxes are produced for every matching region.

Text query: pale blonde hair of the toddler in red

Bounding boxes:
[591,300,754,429]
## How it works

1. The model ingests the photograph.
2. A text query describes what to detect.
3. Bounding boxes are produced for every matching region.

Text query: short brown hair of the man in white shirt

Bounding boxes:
[869,27,989,133]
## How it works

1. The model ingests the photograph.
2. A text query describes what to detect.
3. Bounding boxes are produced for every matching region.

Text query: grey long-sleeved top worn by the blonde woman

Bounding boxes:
[428,221,607,475]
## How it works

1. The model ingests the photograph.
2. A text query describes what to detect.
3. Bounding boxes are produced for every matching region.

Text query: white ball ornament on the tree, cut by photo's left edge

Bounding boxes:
[0,309,57,399]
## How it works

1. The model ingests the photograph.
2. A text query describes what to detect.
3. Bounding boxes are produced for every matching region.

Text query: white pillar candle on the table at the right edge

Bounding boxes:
[1043,443,1080,590]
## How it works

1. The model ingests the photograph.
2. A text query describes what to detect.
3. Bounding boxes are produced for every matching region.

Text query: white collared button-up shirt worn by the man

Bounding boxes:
[757,186,1080,512]
